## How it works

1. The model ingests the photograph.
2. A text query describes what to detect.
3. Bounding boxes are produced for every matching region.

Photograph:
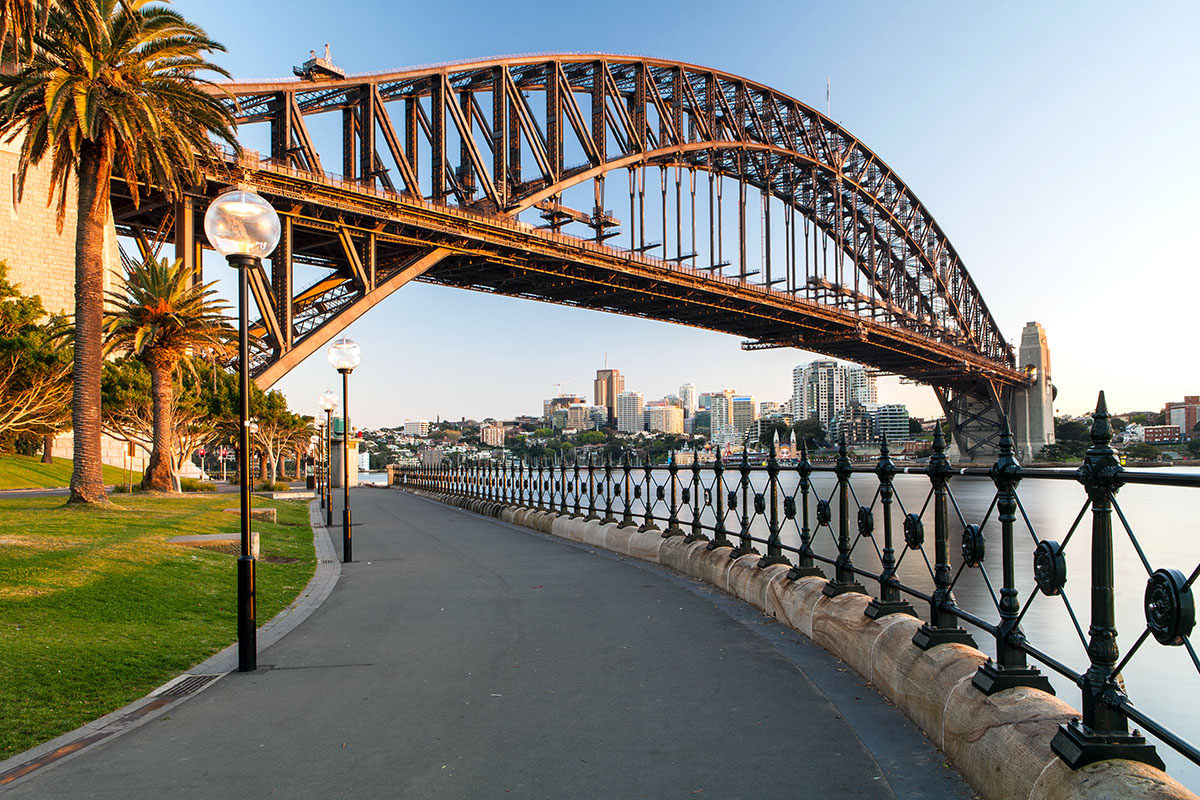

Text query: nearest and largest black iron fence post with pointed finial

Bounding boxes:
[1050,392,1165,769]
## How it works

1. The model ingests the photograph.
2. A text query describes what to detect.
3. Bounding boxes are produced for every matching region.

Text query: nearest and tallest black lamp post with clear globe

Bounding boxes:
[204,190,280,672]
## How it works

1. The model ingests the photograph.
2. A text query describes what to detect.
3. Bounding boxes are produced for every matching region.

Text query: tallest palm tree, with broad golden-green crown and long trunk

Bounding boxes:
[0,0,238,503]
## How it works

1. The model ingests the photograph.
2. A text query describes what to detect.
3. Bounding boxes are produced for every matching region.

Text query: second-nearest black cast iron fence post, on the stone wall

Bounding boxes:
[962,416,1054,694]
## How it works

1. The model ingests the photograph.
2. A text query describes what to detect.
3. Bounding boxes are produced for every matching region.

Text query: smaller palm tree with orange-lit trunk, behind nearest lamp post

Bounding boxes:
[104,259,238,492]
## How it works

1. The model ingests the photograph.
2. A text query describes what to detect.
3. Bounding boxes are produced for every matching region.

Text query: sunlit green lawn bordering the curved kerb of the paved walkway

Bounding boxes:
[0,495,316,760]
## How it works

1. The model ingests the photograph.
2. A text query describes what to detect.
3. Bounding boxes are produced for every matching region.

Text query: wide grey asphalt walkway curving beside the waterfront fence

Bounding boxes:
[8,489,972,800]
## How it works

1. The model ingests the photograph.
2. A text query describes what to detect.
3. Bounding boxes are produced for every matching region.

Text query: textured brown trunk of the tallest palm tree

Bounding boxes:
[70,142,112,504]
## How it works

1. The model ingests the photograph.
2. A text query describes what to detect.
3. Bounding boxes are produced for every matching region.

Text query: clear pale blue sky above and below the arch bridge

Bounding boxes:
[174,0,1200,427]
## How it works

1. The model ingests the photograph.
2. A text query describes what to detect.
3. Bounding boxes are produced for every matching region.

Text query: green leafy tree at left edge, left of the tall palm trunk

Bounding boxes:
[0,261,71,461]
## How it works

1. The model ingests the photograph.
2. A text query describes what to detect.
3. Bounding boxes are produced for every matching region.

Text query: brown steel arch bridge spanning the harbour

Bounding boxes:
[113,54,1028,457]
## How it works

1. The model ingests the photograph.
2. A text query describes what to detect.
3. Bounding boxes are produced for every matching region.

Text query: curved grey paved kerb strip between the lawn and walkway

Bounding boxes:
[0,500,342,790]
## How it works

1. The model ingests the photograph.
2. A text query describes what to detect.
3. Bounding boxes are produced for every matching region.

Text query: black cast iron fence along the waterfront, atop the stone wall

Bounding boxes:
[391,392,1200,786]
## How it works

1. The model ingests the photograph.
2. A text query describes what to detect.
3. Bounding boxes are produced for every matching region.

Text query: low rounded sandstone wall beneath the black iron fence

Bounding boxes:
[406,487,1200,800]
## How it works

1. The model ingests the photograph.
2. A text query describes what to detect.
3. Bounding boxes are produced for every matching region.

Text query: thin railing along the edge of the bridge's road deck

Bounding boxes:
[214,144,961,357]
